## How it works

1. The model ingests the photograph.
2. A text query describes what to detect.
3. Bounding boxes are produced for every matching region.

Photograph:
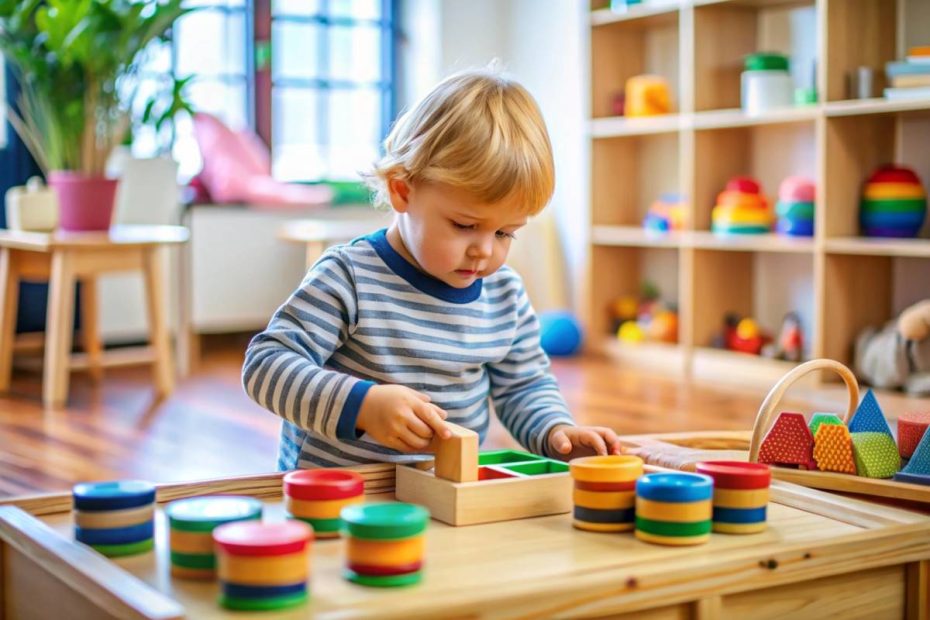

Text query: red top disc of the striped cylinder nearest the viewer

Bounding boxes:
[213,521,313,555]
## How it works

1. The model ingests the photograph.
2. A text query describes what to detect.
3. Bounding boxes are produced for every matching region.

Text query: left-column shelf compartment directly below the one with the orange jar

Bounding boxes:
[591,133,681,226]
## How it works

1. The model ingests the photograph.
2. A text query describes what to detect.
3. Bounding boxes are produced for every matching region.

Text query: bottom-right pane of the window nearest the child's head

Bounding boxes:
[328,89,381,180]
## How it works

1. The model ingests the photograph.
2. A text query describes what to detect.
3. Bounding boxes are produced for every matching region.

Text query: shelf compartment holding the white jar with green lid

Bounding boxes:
[694,0,817,112]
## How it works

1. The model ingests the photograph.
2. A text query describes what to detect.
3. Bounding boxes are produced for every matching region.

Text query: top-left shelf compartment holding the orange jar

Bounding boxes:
[591,10,679,118]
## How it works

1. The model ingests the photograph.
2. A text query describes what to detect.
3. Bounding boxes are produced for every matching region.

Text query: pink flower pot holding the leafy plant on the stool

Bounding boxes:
[48,170,118,231]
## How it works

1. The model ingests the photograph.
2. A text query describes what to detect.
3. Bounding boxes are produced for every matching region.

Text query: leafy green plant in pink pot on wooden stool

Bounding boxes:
[0,0,187,230]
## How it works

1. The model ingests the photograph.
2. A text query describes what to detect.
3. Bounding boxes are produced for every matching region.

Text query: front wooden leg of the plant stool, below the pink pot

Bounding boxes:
[42,250,76,407]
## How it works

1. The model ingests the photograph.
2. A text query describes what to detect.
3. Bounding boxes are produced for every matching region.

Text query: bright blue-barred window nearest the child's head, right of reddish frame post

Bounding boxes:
[271,0,394,181]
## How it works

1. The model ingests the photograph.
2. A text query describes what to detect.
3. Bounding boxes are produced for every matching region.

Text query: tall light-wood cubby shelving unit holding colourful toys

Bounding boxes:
[585,0,930,385]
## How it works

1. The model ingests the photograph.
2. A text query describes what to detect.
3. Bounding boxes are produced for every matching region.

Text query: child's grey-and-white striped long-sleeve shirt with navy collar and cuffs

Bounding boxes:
[242,230,573,469]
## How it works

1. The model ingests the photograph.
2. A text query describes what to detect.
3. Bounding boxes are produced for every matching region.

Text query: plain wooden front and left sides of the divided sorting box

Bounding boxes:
[394,465,572,525]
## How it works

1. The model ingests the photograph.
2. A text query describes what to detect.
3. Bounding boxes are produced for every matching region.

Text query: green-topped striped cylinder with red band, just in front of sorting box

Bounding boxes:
[342,502,429,588]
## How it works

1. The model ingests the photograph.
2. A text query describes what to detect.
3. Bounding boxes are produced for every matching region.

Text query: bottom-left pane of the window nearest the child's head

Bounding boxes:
[271,88,326,181]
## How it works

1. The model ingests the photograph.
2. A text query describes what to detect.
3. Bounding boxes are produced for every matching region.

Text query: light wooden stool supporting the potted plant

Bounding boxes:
[0,226,188,406]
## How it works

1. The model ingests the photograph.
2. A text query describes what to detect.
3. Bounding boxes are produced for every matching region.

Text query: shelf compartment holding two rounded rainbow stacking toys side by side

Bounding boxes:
[694,122,817,230]
